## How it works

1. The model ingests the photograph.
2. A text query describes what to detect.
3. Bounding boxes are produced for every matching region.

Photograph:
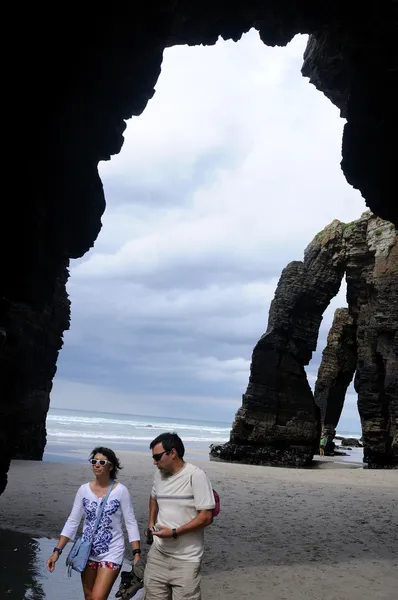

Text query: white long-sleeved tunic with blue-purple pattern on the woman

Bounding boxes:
[61,483,140,565]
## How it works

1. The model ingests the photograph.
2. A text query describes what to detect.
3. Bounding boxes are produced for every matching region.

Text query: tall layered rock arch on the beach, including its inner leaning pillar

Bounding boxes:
[210,212,398,468]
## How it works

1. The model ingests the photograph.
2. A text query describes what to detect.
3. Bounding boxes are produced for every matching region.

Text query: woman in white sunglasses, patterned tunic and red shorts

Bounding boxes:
[47,447,141,600]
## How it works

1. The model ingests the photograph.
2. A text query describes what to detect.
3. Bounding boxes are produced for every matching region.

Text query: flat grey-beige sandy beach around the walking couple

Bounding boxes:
[0,452,398,600]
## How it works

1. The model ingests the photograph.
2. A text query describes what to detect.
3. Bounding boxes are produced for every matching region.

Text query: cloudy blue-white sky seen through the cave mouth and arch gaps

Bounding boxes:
[52,31,366,430]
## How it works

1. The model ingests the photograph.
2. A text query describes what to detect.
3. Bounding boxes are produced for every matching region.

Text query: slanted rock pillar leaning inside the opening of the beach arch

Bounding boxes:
[314,308,357,454]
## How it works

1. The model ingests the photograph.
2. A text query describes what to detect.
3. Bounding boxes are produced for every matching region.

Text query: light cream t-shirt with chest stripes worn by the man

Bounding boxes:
[151,463,215,561]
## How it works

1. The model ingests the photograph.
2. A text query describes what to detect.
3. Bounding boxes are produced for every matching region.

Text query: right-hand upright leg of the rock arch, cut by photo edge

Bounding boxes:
[346,214,398,468]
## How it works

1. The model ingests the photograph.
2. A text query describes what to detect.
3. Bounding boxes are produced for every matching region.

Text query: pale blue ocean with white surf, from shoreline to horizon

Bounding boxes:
[43,408,361,462]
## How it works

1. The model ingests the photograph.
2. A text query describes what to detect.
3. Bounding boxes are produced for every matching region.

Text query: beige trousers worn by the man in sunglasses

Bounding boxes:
[144,546,201,600]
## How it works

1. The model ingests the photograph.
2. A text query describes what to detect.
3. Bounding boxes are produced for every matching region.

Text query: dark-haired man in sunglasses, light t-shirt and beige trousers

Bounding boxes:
[144,433,215,600]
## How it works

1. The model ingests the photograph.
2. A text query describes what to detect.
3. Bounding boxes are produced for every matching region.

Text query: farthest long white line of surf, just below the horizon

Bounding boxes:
[47,414,231,437]
